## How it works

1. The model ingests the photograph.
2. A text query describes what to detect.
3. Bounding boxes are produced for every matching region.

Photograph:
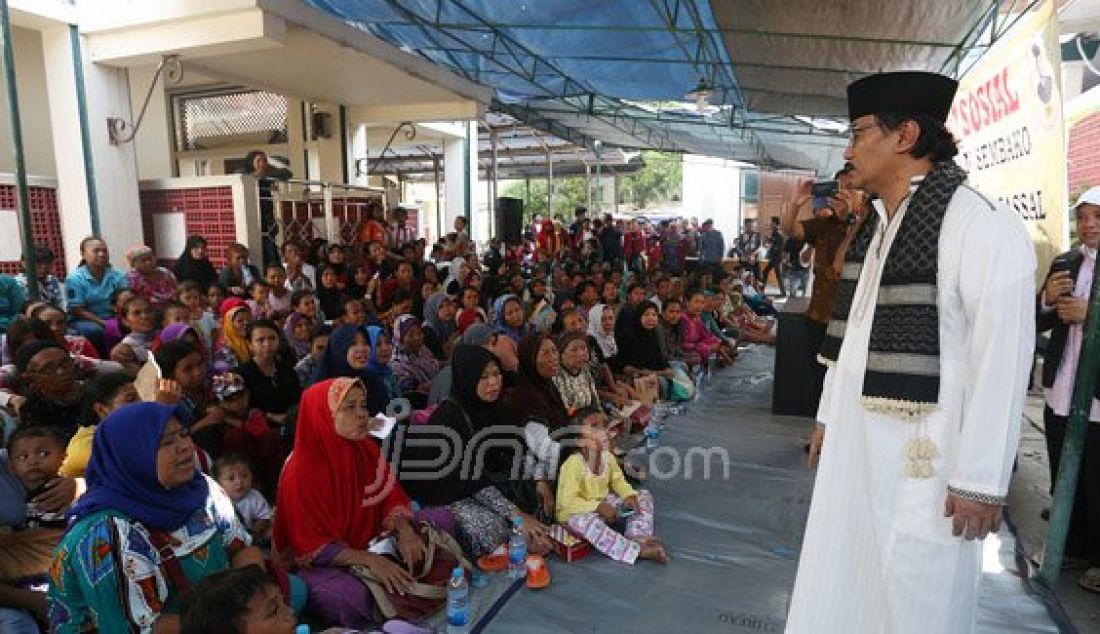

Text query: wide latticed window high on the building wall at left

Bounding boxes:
[174,90,287,151]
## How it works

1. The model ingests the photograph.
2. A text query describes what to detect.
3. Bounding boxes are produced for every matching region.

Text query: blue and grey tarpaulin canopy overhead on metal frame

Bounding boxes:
[307,0,1026,170]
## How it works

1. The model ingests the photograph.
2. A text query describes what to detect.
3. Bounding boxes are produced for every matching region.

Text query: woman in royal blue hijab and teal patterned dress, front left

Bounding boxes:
[48,403,263,632]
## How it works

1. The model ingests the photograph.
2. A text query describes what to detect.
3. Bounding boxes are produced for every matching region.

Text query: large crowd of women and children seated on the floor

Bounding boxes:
[0,217,774,632]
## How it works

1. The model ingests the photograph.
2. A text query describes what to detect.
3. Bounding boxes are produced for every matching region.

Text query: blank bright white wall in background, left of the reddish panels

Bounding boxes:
[683,154,745,249]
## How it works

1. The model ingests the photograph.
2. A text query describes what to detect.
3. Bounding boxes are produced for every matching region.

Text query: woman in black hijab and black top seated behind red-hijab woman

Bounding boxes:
[399,346,550,557]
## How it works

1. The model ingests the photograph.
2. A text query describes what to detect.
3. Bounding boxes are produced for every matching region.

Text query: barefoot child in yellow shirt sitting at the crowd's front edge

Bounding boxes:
[556,407,669,564]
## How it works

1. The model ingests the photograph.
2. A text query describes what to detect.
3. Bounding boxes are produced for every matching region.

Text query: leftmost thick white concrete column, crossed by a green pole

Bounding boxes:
[42,28,147,271]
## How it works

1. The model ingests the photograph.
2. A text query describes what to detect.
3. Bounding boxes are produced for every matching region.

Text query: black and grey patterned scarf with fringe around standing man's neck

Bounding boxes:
[818,161,966,417]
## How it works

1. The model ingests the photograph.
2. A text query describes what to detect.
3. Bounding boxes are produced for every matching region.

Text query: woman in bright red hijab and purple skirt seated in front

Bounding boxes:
[272,378,453,630]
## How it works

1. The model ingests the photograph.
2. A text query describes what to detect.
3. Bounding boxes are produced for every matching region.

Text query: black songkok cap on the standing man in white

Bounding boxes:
[848,70,958,122]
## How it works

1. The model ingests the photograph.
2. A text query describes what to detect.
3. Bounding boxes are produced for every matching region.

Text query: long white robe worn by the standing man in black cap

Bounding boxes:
[787,183,1036,634]
